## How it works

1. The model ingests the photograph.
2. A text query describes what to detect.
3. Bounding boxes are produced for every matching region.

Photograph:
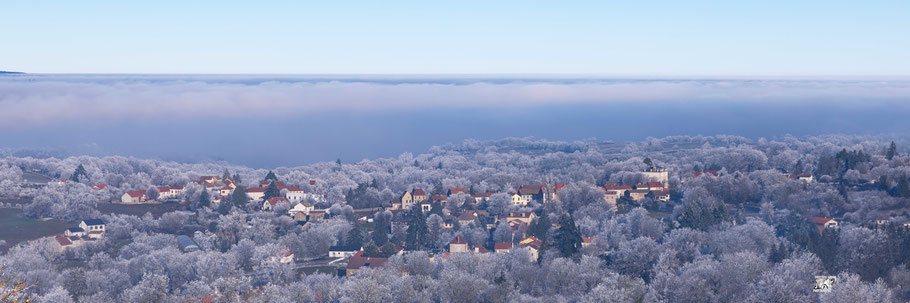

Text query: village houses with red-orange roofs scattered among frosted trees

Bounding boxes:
[42,166,876,276]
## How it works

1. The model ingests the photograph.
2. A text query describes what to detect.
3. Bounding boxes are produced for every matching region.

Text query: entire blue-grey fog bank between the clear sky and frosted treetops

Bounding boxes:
[0,75,910,167]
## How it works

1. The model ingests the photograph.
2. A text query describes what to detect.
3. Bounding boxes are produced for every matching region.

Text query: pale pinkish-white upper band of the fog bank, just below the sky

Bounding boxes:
[0,75,910,128]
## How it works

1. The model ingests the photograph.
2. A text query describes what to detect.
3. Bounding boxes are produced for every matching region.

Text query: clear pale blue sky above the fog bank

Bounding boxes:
[0,0,910,76]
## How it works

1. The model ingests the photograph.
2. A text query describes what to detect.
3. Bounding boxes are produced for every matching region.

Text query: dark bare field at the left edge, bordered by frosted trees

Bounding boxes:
[0,208,77,252]
